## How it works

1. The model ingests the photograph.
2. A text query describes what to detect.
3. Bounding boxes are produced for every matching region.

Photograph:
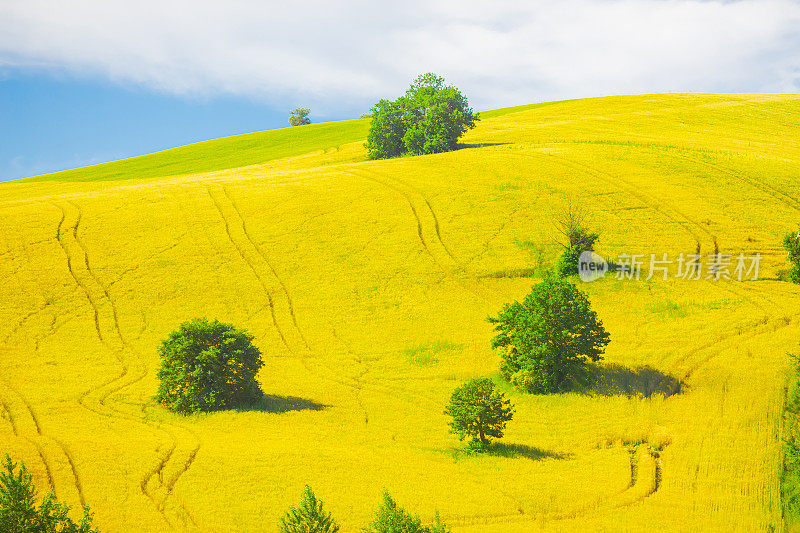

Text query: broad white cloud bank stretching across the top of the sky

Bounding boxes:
[0,0,800,115]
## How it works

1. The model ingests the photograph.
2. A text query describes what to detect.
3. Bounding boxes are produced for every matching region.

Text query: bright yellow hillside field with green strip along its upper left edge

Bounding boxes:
[0,94,800,533]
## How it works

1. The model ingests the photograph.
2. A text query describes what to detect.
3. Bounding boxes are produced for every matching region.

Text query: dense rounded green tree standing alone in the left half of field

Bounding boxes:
[157,318,264,413]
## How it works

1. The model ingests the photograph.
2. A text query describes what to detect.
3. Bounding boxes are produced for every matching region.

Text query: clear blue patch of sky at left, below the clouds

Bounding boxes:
[0,69,334,181]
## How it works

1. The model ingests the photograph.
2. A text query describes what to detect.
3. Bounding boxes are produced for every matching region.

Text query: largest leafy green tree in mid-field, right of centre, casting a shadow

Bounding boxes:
[488,275,610,393]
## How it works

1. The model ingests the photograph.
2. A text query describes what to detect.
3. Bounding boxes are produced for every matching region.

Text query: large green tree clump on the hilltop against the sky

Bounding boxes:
[365,73,479,159]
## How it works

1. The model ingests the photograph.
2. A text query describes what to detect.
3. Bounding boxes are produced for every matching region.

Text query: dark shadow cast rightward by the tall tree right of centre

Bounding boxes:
[577,363,683,398]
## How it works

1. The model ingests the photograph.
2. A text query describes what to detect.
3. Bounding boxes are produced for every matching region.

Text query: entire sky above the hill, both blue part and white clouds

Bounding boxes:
[0,0,800,181]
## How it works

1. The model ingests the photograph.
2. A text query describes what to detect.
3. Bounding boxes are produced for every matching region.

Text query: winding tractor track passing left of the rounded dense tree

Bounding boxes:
[56,202,201,528]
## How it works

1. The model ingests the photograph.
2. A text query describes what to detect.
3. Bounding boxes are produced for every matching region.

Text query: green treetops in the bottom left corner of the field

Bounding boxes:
[0,455,99,533]
